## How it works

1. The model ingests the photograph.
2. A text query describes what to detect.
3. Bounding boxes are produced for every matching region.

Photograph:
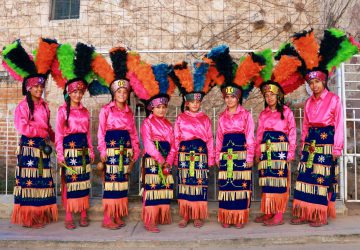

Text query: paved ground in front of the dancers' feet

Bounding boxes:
[0,215,360,250]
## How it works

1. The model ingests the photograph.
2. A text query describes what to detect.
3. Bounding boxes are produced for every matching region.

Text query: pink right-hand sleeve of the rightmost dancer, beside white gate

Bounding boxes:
[333,96,344,156]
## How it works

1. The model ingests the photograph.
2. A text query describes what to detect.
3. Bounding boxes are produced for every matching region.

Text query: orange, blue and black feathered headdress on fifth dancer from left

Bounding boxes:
[170,61,214,103]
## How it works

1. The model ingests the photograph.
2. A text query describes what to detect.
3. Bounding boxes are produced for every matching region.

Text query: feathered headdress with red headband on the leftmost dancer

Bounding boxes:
[2,38,58,95]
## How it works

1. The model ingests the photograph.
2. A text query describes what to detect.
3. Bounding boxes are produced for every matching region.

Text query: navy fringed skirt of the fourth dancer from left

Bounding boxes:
[142,141,174,224]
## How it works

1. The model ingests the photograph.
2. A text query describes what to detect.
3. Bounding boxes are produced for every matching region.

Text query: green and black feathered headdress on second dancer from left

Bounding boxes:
[51,43,108,98]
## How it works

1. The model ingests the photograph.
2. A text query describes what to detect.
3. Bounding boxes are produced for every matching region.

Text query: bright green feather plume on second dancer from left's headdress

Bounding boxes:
[56,43,76,80]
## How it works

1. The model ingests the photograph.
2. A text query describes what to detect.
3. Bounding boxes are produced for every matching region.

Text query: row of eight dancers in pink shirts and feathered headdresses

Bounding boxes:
[3,29,358,232]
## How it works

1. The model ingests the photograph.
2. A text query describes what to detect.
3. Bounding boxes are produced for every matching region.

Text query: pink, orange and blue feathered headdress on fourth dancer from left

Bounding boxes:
[128,60,175,111]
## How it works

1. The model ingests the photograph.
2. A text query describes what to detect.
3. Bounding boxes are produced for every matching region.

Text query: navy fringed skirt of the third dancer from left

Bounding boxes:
[103,130,133,218]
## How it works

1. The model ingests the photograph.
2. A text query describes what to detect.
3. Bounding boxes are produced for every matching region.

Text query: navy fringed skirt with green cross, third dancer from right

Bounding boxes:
[218,134,251,224]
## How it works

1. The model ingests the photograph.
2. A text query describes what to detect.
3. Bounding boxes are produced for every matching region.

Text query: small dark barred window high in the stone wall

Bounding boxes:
[50,0,80,20]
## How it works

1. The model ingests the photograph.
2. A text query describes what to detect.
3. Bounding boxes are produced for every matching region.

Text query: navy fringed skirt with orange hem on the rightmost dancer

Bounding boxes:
[293,126,339,222]
